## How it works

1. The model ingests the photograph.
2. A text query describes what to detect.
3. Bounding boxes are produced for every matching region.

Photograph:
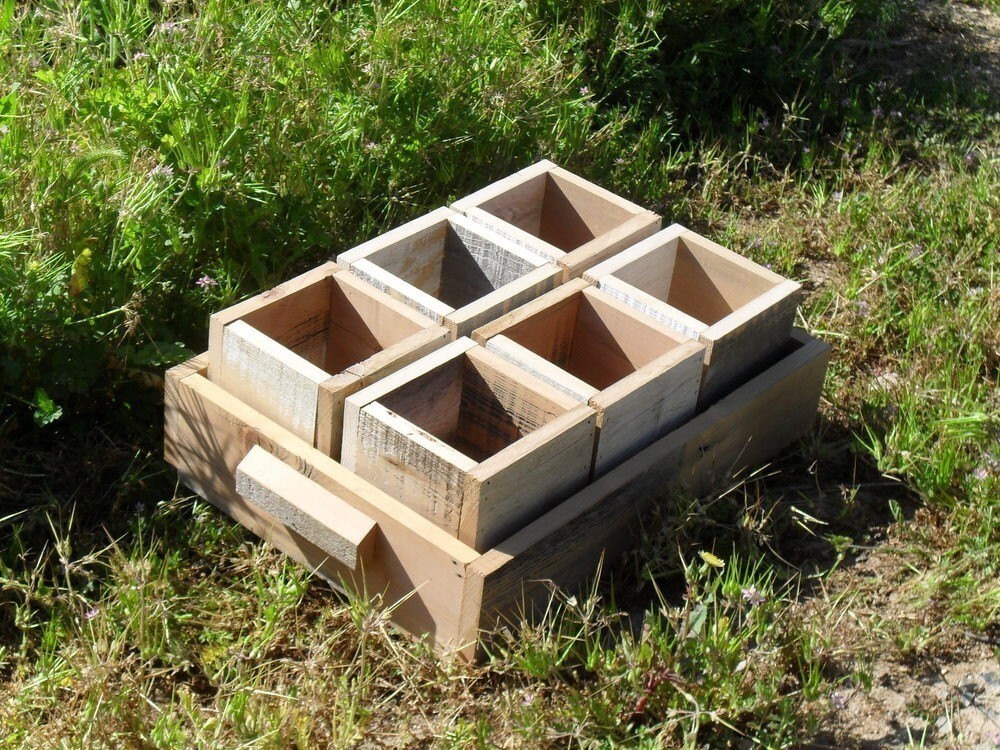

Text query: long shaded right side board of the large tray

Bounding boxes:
[470,331,829,629]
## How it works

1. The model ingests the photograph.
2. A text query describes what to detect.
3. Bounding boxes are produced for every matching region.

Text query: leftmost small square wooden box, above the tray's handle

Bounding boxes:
[208,263,449,458]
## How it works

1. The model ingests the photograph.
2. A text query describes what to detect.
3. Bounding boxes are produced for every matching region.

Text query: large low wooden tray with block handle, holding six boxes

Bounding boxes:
[165,331,828,658]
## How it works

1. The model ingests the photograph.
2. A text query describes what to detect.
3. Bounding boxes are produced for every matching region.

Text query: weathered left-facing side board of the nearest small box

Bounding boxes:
[354,402,476,536]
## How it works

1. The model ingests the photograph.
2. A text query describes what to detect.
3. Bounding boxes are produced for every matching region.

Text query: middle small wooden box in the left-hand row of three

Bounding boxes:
[337,208,560,338]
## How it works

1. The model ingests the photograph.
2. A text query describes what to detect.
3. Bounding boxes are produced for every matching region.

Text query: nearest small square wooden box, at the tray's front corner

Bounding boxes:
[343,338,596,551]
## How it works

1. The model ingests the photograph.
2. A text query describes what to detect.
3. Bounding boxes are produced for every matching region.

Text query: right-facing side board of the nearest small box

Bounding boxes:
[459,405,596,551]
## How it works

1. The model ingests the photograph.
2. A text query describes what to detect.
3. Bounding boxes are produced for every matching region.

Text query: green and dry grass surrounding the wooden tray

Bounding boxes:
[0,0,1000,748]
